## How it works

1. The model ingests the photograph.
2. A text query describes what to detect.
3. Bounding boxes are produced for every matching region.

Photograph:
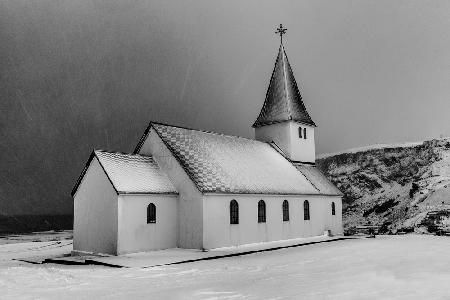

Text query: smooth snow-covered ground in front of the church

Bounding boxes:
[0,235,450,299]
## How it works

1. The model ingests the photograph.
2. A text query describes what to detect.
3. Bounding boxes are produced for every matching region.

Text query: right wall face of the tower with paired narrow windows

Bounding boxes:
[289,121,316,162]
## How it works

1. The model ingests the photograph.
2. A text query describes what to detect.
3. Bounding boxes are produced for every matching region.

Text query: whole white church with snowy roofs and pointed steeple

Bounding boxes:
[72,32,343,255]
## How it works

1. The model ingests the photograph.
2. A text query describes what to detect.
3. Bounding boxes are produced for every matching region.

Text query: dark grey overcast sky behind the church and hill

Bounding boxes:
[0,0,450,214]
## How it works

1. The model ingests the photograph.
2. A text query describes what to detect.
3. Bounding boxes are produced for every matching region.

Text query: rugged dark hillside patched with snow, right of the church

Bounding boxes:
[317,139,450,232]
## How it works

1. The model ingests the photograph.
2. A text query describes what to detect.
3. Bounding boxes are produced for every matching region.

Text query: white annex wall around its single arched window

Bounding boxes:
[117,194,178,254]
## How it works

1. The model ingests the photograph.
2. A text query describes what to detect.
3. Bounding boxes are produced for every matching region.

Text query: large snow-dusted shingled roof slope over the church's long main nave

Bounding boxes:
[152,123,320,195]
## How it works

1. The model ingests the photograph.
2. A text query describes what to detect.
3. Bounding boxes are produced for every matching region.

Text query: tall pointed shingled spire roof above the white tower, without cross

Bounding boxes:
[253,44,316,127]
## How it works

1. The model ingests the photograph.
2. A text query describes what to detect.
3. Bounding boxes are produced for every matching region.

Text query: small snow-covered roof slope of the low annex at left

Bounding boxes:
[94,151,177,194]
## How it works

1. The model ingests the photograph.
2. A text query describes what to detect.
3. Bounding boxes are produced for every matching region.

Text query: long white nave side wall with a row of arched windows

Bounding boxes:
[203,195,343,249]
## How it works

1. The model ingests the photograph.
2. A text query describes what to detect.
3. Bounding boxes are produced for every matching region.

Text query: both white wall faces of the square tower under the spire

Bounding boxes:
[255,121,316,162]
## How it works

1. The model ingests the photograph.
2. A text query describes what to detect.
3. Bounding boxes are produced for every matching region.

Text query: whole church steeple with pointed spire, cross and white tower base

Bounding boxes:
[252,24,316,163]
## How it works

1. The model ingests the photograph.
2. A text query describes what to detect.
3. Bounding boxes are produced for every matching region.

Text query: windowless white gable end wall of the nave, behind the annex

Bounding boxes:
[139,129,203,249]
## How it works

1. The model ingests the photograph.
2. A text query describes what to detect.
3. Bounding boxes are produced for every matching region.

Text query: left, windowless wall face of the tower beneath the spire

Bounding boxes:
[255,122,291,157]
